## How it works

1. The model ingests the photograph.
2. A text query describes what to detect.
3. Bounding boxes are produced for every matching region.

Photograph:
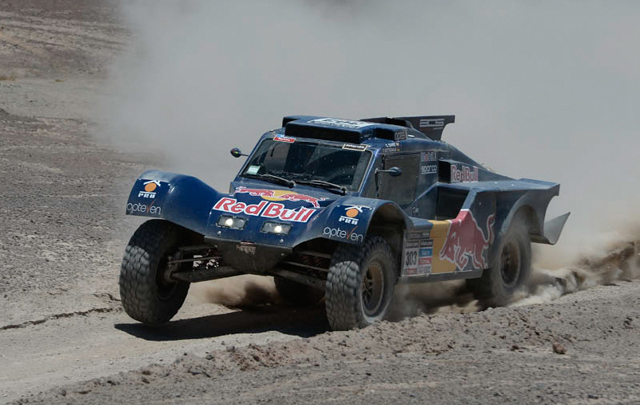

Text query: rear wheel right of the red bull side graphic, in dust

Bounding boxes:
[467,216,531,307]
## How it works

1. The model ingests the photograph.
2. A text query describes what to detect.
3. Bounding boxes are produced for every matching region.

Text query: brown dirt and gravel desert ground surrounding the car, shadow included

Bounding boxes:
[0,0,640,404]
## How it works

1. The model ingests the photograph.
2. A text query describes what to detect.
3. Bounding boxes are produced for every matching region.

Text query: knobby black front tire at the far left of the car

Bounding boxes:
[120,220,192,324]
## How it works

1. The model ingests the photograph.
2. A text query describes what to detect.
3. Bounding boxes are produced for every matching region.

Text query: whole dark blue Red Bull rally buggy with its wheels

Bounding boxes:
[120,116,569,330]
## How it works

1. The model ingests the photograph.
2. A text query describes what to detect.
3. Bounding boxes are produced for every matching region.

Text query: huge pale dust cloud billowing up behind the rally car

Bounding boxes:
[99,0,640,310]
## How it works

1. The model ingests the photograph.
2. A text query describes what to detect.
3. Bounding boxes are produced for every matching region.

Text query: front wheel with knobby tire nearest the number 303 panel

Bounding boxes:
[326,237,397,330]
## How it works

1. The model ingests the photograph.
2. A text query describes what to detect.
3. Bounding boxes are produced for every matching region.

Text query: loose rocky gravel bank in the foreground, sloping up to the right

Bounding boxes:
[12,282,640,404]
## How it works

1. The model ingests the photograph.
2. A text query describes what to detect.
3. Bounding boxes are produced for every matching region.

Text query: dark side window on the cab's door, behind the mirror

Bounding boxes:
[378,154,420,208]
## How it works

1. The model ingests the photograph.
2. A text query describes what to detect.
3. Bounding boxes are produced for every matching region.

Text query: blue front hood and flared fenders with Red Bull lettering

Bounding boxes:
[126,170,378,254]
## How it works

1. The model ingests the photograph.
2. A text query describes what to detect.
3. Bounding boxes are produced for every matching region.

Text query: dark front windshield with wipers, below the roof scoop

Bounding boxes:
[241,138,371,191]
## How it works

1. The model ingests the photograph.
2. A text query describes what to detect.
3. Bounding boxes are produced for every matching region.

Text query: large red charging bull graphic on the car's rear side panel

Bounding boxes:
[440,210,495,270]
